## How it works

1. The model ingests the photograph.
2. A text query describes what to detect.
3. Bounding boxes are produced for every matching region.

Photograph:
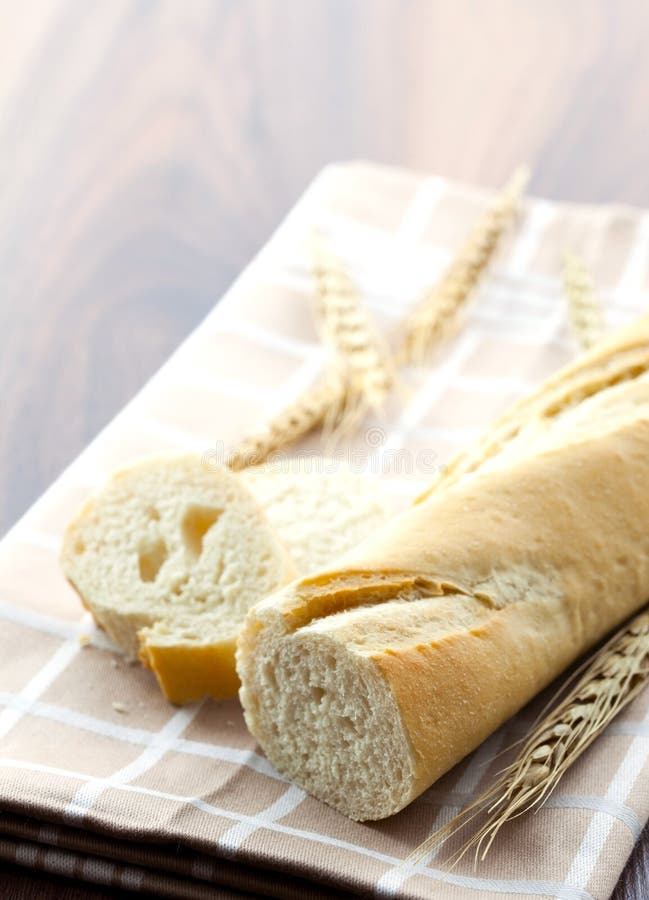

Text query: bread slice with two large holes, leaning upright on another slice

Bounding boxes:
[61,456,296,664]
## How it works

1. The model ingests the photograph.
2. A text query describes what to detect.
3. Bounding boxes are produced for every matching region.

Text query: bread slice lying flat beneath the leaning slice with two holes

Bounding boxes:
[139,457,386,703]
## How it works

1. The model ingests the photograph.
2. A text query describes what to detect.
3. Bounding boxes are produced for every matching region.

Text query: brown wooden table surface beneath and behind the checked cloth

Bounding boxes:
[0,0,649,900]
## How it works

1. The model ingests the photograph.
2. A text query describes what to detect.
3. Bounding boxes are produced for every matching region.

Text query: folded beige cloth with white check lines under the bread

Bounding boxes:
[0,163,649,900]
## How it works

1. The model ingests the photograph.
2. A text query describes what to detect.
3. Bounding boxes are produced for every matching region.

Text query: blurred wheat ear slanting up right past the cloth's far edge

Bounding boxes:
[397,166,529,365]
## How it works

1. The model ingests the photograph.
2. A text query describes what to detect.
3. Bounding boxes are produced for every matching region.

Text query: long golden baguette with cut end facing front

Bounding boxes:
[237,319,649,821]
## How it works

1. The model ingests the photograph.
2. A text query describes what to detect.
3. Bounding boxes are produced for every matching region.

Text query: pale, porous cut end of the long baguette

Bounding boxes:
[238,588,415,821]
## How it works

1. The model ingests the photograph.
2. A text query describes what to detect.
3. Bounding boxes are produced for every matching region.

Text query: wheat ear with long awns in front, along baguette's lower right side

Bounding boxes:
[409,609,649,862]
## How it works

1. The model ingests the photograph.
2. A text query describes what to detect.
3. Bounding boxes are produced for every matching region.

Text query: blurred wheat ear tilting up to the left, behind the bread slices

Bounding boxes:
[311,230,395,432]
